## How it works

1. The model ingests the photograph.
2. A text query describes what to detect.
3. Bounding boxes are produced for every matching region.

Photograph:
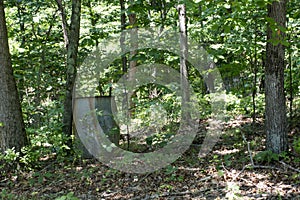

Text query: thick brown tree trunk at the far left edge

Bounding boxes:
[0,0,28,153]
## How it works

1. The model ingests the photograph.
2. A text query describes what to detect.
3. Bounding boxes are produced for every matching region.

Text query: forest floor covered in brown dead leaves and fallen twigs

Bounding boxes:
[0,116,300,200]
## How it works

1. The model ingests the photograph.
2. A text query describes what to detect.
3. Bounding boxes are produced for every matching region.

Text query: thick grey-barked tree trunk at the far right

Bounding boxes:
[265,0,288,153]
